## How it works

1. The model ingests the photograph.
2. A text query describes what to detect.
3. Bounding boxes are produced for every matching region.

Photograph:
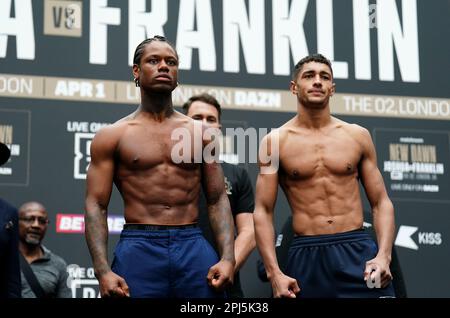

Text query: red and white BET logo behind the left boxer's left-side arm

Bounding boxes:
[56,214,125,234]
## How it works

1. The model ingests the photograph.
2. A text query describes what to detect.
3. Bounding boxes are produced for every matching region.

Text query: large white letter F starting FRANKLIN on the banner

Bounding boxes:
[89,0,120,64]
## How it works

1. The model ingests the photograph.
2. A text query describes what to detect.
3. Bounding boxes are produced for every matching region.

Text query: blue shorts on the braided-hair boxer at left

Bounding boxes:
[112,227,224,298]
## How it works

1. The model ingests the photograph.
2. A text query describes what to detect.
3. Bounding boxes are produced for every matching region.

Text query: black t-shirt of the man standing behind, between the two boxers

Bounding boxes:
[198,162,255,297]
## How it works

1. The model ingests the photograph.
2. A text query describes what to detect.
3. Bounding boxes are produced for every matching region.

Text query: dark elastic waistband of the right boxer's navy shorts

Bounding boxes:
[291,229,372,247]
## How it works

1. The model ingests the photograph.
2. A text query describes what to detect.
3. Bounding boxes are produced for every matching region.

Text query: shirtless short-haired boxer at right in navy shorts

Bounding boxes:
[254,54,395,298]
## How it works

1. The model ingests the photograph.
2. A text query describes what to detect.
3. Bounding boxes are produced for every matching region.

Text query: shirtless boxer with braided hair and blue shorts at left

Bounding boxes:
[85,36,235,298]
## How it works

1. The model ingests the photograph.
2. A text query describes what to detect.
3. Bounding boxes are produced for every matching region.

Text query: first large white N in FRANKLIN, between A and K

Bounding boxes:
[223,0,266,74]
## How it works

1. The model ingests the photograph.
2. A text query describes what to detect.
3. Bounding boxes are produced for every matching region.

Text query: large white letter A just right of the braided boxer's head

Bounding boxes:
[177,0,216,71]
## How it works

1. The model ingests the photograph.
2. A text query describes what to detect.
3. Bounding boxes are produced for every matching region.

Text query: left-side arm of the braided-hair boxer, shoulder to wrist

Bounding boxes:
[85,128,115,277]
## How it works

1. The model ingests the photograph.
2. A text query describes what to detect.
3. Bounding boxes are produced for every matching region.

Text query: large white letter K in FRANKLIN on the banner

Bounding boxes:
[272,0,308,75]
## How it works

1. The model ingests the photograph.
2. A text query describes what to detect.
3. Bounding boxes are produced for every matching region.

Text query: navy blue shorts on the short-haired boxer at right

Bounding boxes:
[286,230,395,298]
